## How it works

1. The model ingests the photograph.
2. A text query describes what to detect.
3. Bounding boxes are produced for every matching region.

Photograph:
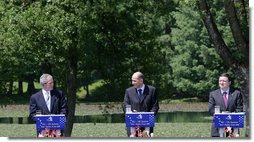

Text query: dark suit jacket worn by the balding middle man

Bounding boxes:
[123,85,159,114]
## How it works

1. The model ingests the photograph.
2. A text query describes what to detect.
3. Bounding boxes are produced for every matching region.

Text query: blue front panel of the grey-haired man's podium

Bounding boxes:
[36,114,66,130]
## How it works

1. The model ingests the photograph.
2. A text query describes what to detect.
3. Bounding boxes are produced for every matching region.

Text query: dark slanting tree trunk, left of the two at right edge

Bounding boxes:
[197,0,250,137]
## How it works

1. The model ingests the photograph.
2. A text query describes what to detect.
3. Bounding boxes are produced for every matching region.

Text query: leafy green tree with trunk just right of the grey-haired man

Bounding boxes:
[2,1,85,136]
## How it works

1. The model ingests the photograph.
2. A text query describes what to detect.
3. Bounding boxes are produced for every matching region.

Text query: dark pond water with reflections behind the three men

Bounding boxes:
[0,111,212,124]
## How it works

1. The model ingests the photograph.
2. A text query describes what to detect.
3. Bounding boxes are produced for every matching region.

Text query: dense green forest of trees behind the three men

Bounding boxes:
[0,0,249,136]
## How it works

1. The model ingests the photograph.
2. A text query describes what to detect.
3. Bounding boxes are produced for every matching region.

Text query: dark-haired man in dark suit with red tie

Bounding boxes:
[208,73,243,137]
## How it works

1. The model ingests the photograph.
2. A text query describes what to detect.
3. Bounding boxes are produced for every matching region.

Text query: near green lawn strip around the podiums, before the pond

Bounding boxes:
[0,123,244,139]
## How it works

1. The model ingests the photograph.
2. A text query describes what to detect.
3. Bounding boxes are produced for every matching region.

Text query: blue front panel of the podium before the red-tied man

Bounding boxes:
[214,113,245,128]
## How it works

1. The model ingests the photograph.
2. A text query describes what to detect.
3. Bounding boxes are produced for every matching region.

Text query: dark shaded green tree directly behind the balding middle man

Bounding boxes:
[81,0,177,101]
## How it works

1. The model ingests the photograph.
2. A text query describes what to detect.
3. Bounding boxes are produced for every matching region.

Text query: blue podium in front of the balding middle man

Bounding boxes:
[125,112,154,137]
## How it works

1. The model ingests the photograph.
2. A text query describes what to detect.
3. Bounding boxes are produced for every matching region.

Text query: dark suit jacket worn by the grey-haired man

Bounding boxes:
[29,90,67,122]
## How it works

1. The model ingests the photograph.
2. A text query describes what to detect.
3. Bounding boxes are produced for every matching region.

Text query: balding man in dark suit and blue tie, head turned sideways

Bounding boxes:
[123,72,159,137]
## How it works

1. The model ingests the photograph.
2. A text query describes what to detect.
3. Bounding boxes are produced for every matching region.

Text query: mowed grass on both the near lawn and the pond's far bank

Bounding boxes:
[0,102,245,139]
